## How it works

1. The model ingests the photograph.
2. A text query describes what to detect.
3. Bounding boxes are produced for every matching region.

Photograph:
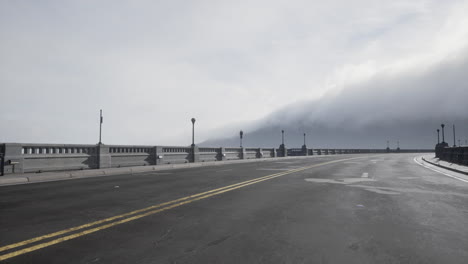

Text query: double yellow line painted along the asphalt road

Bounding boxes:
[0,158,356,261]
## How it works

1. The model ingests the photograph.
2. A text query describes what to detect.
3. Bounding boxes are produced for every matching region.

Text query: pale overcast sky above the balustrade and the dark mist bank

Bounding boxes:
[0,0,468,145]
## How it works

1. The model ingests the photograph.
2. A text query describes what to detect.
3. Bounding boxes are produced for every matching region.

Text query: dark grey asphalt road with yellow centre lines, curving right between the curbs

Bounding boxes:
[0,154,468,263]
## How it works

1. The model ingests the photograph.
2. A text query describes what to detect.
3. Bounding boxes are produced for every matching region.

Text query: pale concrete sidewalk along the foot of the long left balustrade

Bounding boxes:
[0,155,336,186]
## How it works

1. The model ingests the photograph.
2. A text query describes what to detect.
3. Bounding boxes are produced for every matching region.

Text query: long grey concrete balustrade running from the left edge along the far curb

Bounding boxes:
[0,143,432,174]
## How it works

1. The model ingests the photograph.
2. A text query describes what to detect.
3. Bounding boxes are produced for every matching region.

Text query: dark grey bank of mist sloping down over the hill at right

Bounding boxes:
[201,48,468,148]
